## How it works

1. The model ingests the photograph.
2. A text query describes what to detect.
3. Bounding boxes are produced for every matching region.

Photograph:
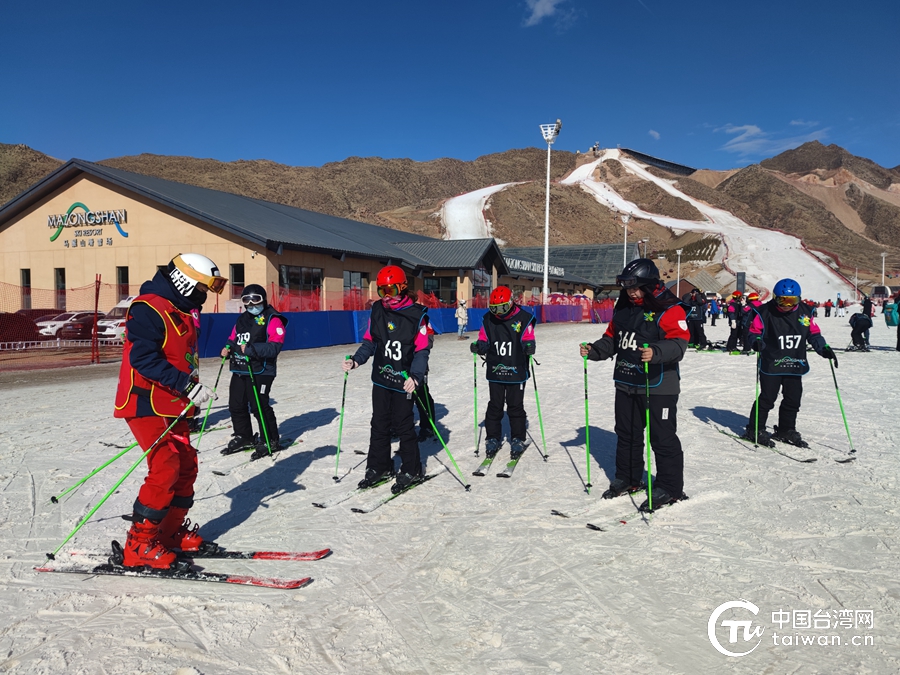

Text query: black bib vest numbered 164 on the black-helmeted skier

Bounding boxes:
[613,305,678,387]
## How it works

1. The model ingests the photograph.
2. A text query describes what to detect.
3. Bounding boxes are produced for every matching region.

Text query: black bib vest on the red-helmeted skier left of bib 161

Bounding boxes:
[369,302,428,391]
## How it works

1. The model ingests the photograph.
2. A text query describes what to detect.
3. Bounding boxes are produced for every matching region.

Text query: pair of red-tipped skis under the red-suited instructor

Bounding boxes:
[34,541,331,589]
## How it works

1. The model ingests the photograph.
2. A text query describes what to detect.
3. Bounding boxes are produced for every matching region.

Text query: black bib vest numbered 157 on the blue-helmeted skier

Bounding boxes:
[757,300,812,375]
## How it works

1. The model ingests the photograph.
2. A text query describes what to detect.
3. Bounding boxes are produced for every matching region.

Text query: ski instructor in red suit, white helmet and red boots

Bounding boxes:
[115,253,225,568]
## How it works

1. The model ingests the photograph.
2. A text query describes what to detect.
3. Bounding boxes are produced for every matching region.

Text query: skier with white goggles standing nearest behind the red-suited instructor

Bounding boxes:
[221,284,288,459]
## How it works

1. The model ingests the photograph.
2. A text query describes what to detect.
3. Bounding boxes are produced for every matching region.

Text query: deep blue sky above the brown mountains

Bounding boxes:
[0,0,900,169]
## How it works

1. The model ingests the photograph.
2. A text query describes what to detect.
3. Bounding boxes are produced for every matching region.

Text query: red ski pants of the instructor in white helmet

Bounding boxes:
[127,417,197,520]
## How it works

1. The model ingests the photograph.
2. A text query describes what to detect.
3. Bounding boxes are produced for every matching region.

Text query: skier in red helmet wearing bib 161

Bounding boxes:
[469,286,536,459]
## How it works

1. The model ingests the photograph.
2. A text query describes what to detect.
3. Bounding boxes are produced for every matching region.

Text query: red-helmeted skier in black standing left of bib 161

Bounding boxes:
[343,265,434,493]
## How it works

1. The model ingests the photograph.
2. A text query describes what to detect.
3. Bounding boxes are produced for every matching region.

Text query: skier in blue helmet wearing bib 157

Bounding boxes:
[744,279,837,447]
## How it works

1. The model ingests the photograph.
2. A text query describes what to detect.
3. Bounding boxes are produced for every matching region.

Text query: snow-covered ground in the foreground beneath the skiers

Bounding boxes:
[0,316,900,675]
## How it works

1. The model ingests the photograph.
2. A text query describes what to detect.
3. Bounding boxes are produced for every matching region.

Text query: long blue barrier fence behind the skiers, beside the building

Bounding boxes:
[198,307,540,358]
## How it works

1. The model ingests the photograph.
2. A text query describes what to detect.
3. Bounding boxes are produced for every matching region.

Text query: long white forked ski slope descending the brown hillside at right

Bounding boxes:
[564,149,856,302]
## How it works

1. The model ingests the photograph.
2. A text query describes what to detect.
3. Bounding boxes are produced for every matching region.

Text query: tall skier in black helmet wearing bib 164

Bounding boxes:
[581,258,690,511]
